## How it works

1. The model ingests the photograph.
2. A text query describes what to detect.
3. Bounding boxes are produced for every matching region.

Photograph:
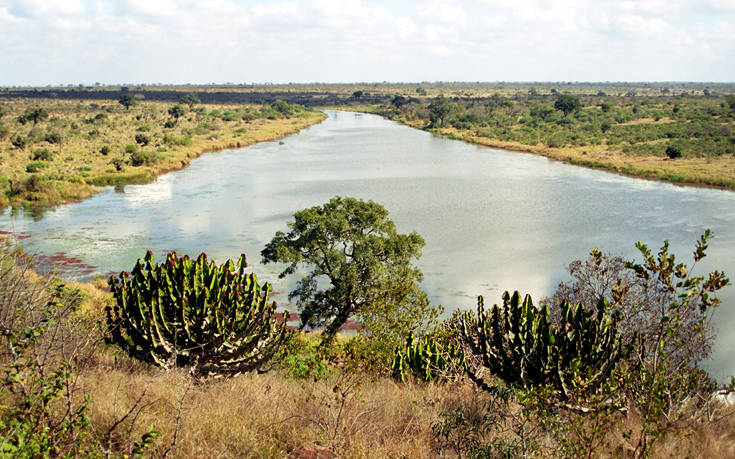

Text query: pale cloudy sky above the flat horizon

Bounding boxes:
[0,0,735,86]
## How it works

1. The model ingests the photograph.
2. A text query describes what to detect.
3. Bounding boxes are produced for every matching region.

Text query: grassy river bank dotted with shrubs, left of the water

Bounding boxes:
[0,99,326,211]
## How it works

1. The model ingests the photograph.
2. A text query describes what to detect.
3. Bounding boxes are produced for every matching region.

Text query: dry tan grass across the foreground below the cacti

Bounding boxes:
[1,274,735,458]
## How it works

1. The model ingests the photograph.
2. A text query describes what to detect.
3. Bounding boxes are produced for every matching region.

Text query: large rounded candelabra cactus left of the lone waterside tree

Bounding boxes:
[106,251,290,377]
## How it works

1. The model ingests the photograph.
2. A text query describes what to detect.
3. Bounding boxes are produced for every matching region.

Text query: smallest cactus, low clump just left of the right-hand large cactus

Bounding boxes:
[391,332,464,382]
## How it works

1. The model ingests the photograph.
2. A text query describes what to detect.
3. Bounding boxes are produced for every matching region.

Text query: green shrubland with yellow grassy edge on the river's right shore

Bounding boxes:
[360,90,735,189]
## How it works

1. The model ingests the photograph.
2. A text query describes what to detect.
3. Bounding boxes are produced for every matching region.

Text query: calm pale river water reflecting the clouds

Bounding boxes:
[0,111,735,377]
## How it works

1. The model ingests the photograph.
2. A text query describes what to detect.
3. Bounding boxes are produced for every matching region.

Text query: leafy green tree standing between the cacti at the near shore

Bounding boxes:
[261,196,424,345]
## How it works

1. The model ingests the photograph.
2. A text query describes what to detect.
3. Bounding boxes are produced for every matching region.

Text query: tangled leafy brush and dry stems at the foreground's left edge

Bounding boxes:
[0,243,99,457]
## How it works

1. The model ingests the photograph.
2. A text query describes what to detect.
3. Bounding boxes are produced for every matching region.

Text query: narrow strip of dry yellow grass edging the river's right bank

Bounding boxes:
[340,105,735,190]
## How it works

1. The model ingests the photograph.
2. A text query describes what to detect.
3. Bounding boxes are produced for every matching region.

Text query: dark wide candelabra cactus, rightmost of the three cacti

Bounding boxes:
[461,292,625,400]
